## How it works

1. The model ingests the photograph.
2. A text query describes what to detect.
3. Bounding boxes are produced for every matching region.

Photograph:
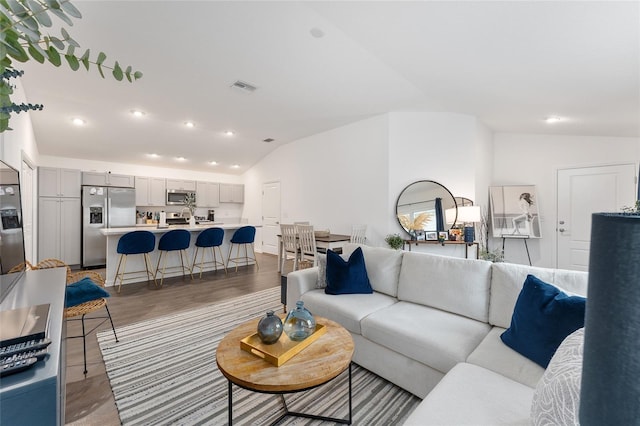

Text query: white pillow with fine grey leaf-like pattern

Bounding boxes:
[531,328,584,426]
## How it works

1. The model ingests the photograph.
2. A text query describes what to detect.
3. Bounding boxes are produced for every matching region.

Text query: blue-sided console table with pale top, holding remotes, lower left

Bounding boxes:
[0,268,66,426]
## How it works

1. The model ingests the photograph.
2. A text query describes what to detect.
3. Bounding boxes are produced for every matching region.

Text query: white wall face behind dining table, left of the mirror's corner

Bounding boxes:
[244,115,389,249]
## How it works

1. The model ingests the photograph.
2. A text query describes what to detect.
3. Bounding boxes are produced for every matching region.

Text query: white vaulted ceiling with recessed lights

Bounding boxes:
[18,0,640,174]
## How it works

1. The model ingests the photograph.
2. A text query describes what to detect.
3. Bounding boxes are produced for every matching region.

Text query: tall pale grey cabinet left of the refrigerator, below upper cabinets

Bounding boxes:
[38,197,82,265]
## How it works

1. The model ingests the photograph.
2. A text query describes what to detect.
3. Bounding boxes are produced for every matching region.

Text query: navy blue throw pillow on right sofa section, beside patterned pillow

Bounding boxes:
[500,275,587,368]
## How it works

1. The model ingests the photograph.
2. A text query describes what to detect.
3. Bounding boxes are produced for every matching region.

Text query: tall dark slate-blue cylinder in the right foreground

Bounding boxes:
[580,213,640,426]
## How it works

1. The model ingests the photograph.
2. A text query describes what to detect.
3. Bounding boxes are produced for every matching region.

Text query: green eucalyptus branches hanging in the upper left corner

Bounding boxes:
[0,0,142,132]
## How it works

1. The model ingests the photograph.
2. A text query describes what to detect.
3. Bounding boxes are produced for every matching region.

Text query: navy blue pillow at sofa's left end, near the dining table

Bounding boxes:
[324,247,373,294]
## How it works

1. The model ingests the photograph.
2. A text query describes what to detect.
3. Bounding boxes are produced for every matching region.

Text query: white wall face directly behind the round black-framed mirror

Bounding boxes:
[387,112,493,255]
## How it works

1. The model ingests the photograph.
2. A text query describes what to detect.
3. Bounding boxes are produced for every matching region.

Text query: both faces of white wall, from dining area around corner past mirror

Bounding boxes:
[245,112,492,251]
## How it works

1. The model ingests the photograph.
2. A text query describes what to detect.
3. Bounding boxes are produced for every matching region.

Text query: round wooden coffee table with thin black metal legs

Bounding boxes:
[216,317,354,425]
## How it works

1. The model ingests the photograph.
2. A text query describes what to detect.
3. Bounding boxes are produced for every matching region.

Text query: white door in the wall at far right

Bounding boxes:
[556,164,636,271]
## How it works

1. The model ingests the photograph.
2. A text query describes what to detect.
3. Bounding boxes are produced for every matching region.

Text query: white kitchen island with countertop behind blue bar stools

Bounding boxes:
[100,223,261,286]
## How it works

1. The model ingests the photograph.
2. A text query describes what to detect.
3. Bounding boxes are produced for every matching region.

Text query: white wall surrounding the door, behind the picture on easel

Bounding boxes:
[492,133,640,267]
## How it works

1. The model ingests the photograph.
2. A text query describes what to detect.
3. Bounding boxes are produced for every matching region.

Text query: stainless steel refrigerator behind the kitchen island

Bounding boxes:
[82,186,136,268]
